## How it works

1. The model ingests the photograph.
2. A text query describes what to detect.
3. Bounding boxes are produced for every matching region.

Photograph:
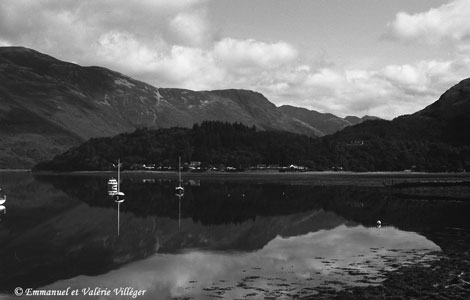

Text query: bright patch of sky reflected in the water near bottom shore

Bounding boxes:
[40,225,438,299]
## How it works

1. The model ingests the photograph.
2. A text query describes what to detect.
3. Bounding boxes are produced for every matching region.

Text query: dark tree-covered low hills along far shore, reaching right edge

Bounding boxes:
[34,120,470,172]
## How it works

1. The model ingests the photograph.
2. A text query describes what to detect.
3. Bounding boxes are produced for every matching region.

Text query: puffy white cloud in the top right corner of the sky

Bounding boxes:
[389,0,470,51]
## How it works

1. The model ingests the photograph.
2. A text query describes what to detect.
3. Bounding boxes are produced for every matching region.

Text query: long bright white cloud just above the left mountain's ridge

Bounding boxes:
[95,31,305,91]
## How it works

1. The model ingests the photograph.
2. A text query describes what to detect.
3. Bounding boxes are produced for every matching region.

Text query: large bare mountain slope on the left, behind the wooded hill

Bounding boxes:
[0,47,321,168]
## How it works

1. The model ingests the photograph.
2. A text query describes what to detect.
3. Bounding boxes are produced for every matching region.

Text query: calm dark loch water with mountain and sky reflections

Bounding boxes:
[0,172,470,299]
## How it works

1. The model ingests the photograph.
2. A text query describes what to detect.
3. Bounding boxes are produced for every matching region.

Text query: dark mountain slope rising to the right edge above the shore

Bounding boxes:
[323,79,470,172]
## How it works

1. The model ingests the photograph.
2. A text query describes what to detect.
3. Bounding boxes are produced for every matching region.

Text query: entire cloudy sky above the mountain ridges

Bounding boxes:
[0,0,470,119]
